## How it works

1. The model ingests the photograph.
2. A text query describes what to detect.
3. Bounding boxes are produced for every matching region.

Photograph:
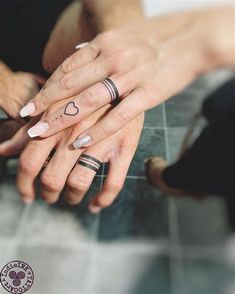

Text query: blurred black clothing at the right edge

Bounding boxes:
[163,78,235,196]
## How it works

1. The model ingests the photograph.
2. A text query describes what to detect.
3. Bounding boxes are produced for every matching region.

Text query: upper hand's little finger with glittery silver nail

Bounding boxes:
[73,89,150,149]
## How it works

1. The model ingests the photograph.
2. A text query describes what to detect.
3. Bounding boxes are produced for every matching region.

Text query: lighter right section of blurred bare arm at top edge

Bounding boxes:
[83,0,143,32]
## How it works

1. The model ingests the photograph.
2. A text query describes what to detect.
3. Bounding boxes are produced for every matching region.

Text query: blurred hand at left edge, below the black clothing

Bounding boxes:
[0,63,45,119]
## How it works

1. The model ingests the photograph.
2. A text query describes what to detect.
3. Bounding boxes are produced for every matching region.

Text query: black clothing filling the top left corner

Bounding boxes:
[0,0,71,75]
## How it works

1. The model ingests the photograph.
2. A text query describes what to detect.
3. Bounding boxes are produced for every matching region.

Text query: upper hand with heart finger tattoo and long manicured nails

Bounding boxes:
[21,8,234,147]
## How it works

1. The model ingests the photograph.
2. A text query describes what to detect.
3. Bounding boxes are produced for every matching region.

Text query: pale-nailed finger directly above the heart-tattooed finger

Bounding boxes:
[20,55,105,117]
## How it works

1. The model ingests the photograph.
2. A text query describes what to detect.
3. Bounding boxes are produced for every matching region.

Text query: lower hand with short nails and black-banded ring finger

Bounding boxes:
[0,106,144,213]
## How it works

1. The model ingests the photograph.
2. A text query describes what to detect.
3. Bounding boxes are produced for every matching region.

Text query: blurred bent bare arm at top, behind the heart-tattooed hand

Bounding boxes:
[43,0,142,72]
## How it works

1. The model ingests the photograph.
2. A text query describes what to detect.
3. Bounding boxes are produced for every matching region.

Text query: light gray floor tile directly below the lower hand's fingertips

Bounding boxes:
[0,176,101,245]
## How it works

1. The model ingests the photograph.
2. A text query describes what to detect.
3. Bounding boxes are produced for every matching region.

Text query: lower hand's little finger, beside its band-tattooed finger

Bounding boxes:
[89,148,135,214]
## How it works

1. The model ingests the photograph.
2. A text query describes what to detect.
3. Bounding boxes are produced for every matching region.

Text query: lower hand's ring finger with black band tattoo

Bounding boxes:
[65,152,104,205]
